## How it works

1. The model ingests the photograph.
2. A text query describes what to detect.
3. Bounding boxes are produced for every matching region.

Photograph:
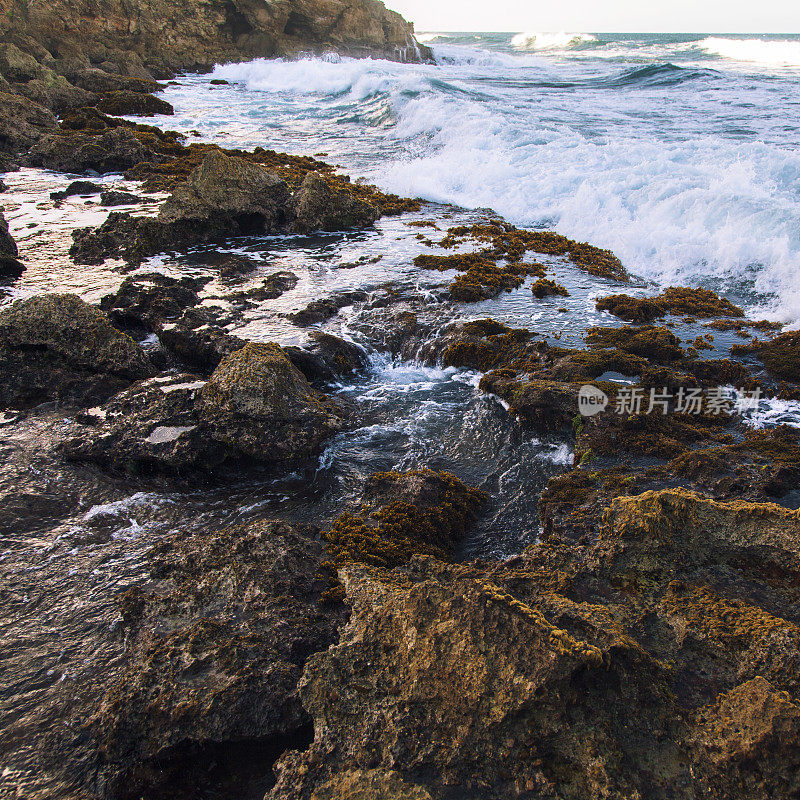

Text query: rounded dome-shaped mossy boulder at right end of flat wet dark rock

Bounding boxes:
[200,342,345,462]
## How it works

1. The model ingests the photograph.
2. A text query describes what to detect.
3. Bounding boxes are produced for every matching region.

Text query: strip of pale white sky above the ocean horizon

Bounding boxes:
[384,0,800,33]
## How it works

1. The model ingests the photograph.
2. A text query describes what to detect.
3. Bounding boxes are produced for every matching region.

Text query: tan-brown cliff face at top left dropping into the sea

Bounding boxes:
[0,0,429,76]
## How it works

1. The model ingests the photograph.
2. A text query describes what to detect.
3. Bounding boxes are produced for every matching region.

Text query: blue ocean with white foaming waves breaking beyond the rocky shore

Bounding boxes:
[141,32,800,327]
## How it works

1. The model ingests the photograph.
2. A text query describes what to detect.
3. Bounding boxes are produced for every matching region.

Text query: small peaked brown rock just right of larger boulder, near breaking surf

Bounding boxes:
[295,172,380,232]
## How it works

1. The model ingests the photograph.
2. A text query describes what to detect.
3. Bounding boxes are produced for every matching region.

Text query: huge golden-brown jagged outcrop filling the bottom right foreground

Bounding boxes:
[269,490,800,800]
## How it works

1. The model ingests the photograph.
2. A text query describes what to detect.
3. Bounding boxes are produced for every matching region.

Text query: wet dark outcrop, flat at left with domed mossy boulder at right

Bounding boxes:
[63,342,345,476]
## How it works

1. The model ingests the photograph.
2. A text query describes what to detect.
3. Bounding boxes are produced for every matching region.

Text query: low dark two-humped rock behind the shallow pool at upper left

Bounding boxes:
[28,127,158,174]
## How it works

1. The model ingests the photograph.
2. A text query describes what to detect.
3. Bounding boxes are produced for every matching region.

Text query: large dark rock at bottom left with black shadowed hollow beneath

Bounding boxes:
[91,520,340,800]
